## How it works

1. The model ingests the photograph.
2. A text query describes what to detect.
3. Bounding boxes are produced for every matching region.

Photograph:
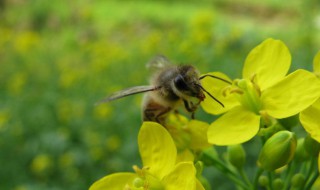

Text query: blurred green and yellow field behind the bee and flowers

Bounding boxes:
[0,0,320,190]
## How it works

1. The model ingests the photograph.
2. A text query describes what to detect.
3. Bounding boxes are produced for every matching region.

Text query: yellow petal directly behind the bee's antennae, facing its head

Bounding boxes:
[201,72,239,115]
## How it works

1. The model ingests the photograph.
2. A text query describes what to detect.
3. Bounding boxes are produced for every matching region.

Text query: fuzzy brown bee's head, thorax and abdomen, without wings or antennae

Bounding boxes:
[142,65,204,124]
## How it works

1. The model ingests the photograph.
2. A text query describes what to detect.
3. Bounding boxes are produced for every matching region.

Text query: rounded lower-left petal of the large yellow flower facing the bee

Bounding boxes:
[208,106,260,145]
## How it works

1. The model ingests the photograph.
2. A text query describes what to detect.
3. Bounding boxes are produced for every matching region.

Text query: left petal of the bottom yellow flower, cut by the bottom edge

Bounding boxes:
[89,173,138,190]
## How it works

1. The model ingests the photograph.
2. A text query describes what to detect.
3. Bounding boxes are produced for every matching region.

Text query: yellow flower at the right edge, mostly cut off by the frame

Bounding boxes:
[300,51,320,143]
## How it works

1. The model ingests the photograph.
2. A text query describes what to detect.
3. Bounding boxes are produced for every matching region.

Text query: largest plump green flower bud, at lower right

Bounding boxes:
[258,131,297,171]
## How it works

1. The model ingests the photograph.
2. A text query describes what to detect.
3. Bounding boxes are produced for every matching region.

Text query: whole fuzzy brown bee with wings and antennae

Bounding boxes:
[98,55,230,124]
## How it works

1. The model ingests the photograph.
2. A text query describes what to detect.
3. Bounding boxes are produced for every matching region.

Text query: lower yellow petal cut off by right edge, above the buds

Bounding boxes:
[300,98,320,143]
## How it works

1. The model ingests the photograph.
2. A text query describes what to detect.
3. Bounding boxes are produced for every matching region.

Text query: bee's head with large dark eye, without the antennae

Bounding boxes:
[173,65,205,101]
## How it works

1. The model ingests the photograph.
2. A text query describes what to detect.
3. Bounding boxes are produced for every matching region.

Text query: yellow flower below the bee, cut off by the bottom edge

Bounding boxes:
[90,122,204,190]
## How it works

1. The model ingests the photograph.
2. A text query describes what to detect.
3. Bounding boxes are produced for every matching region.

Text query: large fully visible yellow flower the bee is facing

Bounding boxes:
[202,39,320,145]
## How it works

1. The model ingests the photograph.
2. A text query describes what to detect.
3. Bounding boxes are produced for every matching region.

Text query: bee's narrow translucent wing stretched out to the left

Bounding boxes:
[96,86,160,105]
